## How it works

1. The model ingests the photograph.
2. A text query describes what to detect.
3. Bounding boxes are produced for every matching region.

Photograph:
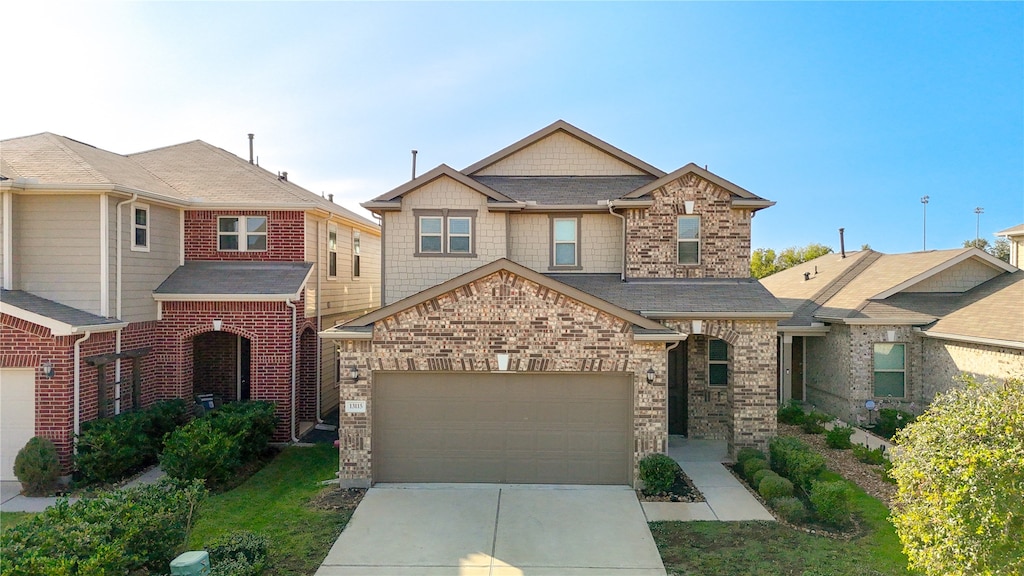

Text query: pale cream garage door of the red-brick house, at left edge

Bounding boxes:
[0,368,36,480]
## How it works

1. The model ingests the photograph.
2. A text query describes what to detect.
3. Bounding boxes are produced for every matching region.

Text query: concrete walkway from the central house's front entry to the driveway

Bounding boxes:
[641,436,775,522]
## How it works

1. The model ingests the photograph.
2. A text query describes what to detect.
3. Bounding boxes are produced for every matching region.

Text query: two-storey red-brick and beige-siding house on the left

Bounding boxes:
[0,133,380,480]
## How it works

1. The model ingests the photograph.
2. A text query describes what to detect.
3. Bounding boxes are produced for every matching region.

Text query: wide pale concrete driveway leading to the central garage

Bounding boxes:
[316,484,666,576]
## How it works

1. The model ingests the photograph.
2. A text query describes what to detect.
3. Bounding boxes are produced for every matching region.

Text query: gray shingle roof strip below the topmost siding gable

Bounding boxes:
[472,175,655,205]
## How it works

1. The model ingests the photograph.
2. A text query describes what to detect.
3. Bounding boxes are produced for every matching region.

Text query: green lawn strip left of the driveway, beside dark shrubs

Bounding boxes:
[189,445,351,576]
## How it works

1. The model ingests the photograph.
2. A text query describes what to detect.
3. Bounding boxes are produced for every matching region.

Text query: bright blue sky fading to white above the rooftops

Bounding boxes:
[0,2,1024,252]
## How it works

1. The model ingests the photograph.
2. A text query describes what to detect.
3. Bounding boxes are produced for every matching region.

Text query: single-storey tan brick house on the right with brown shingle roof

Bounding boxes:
[762,248,1024,422]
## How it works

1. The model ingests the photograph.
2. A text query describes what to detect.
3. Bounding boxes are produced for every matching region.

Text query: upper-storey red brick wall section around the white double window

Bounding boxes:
[185,210,305,262]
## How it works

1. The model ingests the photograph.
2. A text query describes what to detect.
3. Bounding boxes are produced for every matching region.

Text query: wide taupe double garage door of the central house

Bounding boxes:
[372,372,633,484]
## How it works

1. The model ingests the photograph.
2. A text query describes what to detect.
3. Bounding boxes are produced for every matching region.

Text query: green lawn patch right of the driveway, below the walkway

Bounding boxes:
[650,471,912,576]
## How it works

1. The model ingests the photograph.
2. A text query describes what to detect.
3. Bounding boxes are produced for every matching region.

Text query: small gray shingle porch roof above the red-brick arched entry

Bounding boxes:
[153,261,313,299]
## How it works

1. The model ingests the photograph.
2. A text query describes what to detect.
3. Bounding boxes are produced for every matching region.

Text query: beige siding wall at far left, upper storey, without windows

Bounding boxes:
[14,194,100,314]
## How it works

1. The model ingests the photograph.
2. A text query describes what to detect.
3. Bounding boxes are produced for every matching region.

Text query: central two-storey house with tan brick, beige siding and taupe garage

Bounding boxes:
[321,121,790,486]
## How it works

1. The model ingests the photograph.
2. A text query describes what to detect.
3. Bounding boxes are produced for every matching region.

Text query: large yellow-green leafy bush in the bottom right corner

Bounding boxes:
[890,375,1024,575]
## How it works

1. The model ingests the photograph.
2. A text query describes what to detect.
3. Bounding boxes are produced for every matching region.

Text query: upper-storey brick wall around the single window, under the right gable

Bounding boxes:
[626,173,751,278]
